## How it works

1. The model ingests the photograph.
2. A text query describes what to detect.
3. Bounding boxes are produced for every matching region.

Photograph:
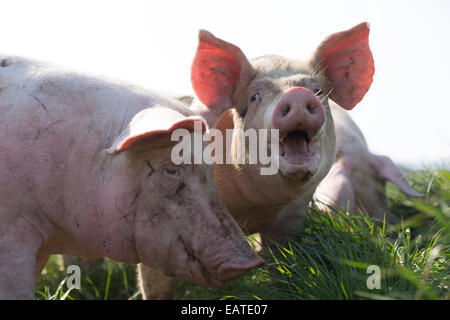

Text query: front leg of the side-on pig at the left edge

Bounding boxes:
[0,216,42,300]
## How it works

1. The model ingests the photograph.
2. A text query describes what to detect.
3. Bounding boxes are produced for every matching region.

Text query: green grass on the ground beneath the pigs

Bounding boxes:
[36,169,450,300]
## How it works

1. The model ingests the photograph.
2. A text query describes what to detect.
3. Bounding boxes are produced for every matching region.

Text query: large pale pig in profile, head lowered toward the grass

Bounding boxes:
[0,56,262,299]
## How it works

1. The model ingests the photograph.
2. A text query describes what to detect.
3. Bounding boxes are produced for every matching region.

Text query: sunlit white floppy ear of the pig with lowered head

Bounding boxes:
[107,107,207,154]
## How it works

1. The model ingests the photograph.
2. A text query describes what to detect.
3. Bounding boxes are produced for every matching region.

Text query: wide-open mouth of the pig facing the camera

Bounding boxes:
[279,130,320,182]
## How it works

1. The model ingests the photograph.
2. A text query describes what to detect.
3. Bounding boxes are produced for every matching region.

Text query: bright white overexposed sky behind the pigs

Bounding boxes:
[0,0,450,167]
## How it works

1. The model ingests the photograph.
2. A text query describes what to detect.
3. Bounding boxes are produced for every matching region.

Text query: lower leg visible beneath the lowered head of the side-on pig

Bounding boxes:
[137,263,177,300]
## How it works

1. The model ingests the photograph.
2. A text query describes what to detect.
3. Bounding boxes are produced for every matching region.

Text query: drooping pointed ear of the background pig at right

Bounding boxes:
[372,156,424,197]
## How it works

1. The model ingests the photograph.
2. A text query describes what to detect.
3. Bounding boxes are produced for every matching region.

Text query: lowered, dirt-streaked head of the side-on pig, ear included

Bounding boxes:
[105,108,262,286]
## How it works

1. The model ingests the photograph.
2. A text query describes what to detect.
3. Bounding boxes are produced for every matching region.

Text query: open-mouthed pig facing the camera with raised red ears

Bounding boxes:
[138,23,375,298]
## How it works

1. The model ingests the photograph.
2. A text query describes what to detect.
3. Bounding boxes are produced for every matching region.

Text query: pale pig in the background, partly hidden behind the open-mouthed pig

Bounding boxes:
[314,103,424,223]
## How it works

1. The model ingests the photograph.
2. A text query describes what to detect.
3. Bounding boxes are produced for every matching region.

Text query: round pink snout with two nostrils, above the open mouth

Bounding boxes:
[272,87,325,140]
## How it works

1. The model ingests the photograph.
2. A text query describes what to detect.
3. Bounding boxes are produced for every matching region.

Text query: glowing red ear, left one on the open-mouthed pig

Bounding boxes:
[191,30,254,114]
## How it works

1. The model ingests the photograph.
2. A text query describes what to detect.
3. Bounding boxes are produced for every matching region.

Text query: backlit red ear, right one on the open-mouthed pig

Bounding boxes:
[312,22,375,110]
